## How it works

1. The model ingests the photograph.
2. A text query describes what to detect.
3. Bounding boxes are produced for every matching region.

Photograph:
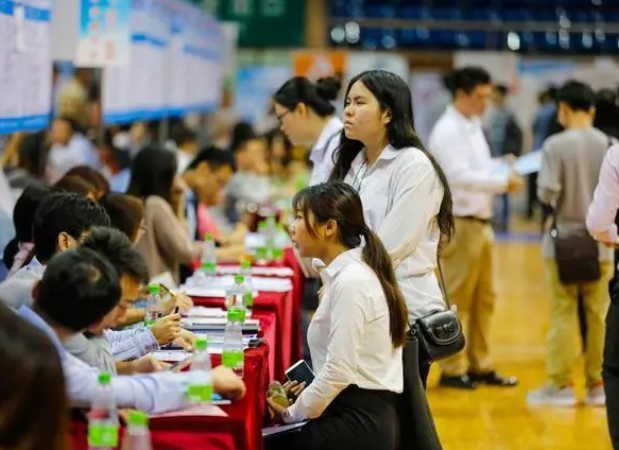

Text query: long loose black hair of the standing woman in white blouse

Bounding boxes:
[330,70,454,240]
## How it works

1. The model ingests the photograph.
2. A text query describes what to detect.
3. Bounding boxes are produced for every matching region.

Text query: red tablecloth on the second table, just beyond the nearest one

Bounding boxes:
[192,292,299,380]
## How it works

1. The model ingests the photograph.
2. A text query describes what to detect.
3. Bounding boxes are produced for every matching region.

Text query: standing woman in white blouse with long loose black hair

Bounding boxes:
[332,70,457,385]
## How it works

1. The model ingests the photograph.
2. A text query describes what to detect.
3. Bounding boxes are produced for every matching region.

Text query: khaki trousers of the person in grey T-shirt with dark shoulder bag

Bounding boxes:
[546,260,613,387]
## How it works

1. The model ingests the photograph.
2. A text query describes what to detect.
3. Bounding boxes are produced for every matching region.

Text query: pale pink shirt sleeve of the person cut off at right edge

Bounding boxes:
[587,144,619,244]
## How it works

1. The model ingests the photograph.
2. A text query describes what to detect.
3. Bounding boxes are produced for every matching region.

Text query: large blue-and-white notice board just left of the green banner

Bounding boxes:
[103,0,223,124]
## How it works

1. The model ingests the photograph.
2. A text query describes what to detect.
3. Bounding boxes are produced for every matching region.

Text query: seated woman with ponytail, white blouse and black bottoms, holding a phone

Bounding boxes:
[267,183,408,450]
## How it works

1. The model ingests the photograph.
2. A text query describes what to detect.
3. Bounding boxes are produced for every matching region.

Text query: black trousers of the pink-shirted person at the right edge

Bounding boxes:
[602,278,619,450]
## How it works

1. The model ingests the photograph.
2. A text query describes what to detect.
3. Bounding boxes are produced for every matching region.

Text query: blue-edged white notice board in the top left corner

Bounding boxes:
[0,0,52,134]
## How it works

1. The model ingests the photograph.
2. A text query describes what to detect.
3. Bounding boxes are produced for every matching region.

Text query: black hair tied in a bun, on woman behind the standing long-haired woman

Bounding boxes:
[273,77,342,117]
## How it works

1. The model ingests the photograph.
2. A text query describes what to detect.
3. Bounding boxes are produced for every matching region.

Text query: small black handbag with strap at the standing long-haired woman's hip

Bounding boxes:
[415,260,465,363]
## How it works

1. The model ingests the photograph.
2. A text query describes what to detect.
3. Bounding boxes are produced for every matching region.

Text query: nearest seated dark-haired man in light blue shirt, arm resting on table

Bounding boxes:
[18,247,245,414]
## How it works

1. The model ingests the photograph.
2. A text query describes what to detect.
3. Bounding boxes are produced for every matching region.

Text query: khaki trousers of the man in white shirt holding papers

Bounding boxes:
[441,218,496,376]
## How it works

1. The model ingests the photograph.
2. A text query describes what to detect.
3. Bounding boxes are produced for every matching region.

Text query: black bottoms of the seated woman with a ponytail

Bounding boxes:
[265,386,399,450]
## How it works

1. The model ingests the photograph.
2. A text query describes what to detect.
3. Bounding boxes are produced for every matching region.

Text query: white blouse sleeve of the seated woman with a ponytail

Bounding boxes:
[284,274,371,423]
